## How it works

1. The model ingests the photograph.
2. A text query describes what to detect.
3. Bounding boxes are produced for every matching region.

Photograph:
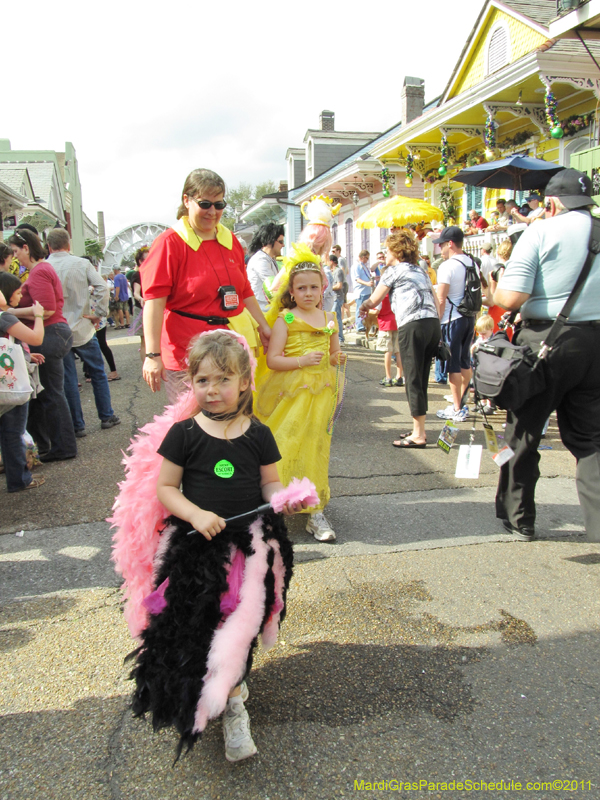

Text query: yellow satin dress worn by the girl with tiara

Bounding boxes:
[256,311,338,513]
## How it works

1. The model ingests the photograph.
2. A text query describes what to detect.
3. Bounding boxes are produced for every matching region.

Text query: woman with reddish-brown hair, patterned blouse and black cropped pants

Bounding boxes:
[360,230,442,448]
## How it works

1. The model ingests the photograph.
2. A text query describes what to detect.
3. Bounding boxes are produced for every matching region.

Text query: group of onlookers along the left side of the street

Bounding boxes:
[0,223,148,492]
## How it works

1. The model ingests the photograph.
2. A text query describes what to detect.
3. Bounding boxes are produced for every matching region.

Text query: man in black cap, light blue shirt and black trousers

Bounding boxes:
[490,169,600,542]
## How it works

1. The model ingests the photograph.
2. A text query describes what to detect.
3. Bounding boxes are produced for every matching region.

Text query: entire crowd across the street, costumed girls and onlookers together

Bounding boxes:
[0,164,600,761]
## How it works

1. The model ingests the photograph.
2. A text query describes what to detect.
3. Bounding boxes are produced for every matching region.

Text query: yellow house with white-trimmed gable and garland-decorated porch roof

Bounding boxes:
[370,0,600,234]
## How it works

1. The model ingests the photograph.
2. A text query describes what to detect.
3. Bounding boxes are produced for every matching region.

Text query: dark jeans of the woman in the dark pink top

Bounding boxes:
[27,322,77,458]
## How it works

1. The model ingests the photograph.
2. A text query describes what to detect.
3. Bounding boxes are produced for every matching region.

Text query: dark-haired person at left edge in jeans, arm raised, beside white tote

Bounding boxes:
[0,272,46,492]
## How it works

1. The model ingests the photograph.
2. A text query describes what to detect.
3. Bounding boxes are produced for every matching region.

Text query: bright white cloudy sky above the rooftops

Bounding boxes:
[5,0,480,235]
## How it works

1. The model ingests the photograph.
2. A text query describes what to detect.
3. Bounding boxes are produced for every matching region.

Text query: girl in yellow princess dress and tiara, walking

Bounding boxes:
[256,260,346,542]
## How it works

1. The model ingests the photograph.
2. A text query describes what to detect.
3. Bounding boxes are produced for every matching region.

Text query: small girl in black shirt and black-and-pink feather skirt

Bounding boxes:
[112,330,317,761]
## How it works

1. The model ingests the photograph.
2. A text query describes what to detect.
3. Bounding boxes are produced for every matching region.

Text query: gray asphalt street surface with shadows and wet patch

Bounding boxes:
[0,328,600,800]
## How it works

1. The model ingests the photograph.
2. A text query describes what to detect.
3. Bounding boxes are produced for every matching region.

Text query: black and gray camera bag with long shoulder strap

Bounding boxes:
[473,212,600,411]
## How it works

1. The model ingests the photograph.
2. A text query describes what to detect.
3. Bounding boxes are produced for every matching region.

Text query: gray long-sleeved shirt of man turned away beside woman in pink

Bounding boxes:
[46,250,109,347]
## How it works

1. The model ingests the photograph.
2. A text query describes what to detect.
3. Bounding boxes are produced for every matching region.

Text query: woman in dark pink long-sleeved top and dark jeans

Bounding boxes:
[8,229,77,462]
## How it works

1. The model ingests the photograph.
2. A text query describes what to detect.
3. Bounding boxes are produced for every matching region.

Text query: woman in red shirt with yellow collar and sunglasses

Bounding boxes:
[140,169,271,402]
